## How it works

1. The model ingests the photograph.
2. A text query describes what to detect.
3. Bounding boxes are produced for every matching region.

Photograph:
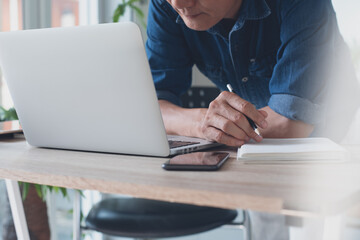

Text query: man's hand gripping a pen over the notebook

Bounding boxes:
[200,91,268,147]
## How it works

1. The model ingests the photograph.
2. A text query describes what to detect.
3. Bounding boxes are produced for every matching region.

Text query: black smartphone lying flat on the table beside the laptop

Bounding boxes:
[162,152,230,171]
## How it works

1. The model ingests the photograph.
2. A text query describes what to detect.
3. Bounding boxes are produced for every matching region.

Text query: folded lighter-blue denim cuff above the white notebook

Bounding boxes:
[268,94,325,125]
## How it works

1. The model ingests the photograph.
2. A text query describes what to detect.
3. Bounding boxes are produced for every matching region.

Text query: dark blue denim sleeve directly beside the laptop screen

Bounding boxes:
[146,0,193,105]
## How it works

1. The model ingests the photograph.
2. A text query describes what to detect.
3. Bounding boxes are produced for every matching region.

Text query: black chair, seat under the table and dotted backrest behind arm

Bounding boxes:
[82,87,249,238]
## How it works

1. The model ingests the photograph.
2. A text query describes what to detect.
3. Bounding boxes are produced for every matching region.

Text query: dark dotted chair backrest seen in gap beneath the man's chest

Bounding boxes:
[181,87,220,108]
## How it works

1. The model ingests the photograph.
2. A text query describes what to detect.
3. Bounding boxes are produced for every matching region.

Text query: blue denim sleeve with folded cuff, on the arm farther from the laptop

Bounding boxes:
[268,0,338,125]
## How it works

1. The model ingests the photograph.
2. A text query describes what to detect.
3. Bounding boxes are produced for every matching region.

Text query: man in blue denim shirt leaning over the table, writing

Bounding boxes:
[146,0,358,146]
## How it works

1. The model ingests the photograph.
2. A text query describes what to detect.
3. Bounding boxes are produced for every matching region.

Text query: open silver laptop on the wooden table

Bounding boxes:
[0,22,218,156]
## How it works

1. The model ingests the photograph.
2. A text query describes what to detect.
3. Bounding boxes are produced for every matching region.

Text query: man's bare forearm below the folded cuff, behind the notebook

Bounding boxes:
[259,106,314,138]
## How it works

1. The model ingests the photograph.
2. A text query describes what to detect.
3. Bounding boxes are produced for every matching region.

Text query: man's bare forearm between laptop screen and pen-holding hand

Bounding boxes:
[159,100,206,137]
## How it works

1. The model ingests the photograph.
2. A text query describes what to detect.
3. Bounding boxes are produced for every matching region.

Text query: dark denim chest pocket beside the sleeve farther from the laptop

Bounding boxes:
[249,51,276,79]
